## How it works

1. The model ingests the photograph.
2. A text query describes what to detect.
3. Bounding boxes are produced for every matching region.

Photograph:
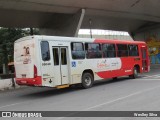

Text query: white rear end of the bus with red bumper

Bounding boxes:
[14,37,42,86]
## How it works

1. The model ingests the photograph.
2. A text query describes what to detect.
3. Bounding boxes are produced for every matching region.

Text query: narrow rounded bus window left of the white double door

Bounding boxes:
[41,41,50,61]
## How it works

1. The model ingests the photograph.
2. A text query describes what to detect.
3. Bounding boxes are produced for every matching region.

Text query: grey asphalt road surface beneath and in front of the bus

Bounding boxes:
[0,67,160,120]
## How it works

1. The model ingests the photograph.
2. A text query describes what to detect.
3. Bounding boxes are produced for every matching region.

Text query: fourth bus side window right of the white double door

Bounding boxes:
[117,44,128,57]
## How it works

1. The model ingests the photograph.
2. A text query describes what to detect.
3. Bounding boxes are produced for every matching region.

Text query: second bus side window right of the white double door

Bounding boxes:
[85,43,102,58]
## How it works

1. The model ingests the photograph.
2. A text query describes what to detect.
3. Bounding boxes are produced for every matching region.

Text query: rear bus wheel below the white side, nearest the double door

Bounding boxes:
[82,73,93,89]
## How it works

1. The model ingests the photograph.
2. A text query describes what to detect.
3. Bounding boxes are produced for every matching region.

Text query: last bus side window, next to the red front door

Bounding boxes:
[128,45,139,56]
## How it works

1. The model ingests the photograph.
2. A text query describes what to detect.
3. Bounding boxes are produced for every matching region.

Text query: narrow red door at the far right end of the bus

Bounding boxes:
[141,47,148,72]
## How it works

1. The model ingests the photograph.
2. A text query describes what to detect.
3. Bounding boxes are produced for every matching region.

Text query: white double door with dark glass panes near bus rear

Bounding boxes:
[52,47,69,85]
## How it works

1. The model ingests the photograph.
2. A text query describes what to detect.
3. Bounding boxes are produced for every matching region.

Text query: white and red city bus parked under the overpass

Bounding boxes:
[14,35,150,88]
